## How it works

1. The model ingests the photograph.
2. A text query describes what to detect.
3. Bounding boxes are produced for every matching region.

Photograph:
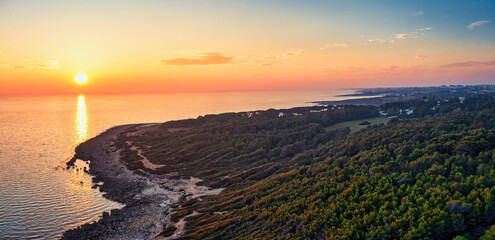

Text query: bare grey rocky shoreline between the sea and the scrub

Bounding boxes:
[61,125,221,239]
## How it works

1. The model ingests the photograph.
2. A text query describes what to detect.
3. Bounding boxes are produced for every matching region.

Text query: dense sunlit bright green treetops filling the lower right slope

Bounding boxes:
[179,115,495,239]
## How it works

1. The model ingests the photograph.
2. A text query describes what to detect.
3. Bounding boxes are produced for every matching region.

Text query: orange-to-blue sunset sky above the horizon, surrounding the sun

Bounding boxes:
[0,0,495,94]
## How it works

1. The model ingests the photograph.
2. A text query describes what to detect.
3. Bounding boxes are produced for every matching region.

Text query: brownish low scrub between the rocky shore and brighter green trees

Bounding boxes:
[115,106,378,187]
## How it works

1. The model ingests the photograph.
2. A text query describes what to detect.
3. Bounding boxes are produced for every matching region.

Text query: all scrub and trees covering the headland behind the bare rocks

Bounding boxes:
[116,95,495,239]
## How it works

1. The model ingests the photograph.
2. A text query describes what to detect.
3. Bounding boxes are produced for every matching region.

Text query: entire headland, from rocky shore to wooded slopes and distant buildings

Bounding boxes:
[66,86,495,239]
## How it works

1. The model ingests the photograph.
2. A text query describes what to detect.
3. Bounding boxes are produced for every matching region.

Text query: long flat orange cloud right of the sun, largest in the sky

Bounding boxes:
[160,52,234,66]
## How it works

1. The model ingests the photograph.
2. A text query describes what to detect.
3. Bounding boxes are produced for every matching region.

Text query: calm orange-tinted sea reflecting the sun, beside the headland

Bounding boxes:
[0,90,362,239]
